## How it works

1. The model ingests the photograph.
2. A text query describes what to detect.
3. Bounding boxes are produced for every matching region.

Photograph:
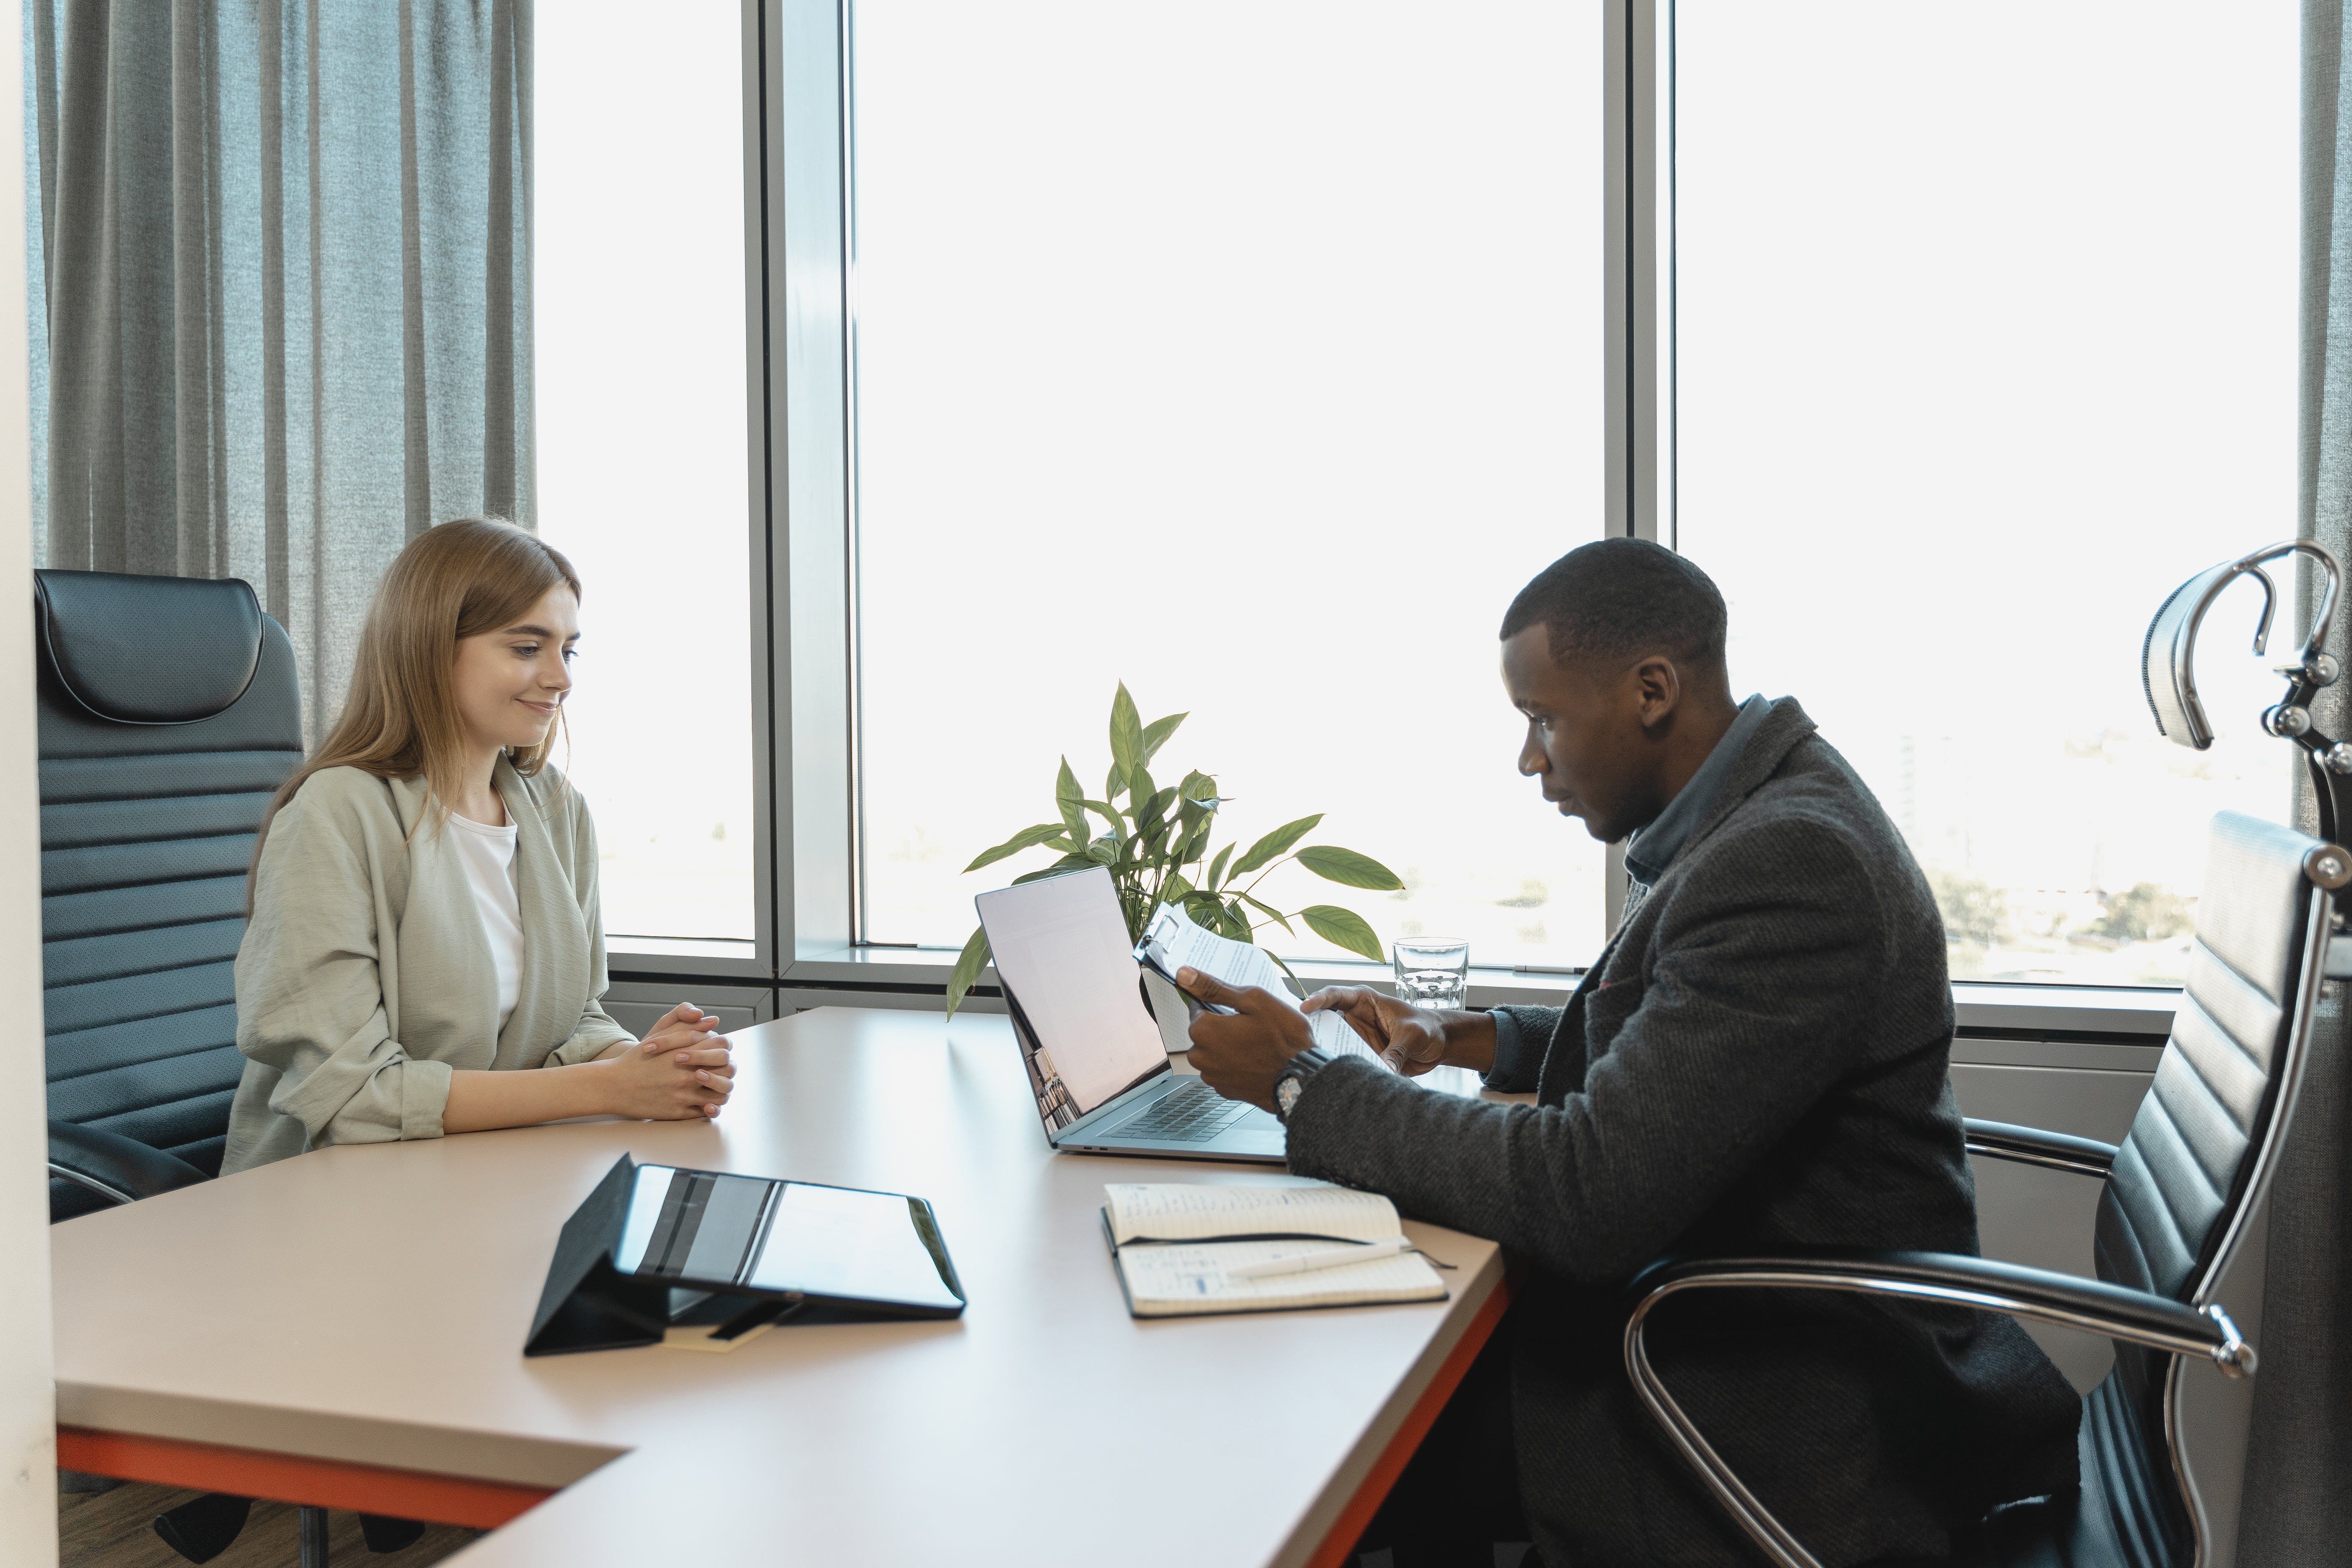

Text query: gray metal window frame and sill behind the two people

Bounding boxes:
[609,0,2178,1039]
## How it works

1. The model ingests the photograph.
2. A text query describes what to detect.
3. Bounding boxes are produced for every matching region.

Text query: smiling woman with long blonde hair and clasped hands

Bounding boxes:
[221,520,734,1173]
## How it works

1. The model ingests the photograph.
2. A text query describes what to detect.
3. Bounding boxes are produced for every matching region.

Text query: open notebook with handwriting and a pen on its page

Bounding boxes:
[1103,1183,1447,1317]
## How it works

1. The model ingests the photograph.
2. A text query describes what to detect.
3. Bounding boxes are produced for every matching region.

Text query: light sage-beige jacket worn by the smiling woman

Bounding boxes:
[221,757,631,1173]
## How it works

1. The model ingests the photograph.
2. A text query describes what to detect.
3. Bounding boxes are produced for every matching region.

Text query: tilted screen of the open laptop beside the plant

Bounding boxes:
[974,867,1166,1128]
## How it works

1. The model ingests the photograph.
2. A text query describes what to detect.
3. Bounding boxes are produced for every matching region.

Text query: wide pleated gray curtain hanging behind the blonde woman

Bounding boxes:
[23,0,534,736]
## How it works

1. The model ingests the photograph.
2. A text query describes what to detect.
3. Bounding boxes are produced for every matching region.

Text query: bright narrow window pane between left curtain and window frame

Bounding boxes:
[534,0,753,945]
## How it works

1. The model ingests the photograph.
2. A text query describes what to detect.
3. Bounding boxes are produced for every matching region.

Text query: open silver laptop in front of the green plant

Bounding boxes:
[974,867,1282,1163]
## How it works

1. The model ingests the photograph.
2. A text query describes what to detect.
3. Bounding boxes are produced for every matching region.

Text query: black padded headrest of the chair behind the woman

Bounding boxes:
[33,571,261,724]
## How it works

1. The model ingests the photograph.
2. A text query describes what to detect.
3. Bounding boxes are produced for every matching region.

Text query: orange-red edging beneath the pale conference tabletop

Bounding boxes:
[56,1277,1510,1568]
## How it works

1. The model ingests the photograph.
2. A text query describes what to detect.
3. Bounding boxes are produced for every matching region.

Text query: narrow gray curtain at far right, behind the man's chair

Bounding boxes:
[2237,0,2352,1563]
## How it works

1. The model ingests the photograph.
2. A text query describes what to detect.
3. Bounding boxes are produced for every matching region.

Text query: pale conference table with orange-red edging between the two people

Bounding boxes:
[52,1008,1508,1568]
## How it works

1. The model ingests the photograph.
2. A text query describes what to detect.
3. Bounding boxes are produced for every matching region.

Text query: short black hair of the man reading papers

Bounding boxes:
[1503,538,1726,665]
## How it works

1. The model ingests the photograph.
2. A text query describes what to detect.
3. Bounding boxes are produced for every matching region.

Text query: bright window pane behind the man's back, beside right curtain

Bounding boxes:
[1675,0,2298,985]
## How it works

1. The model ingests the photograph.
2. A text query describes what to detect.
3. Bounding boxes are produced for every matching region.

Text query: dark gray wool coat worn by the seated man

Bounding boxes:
[1289,698,2079,1568]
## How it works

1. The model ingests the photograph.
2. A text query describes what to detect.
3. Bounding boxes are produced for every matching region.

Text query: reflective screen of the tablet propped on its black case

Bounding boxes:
[611,1166,964,1312]
